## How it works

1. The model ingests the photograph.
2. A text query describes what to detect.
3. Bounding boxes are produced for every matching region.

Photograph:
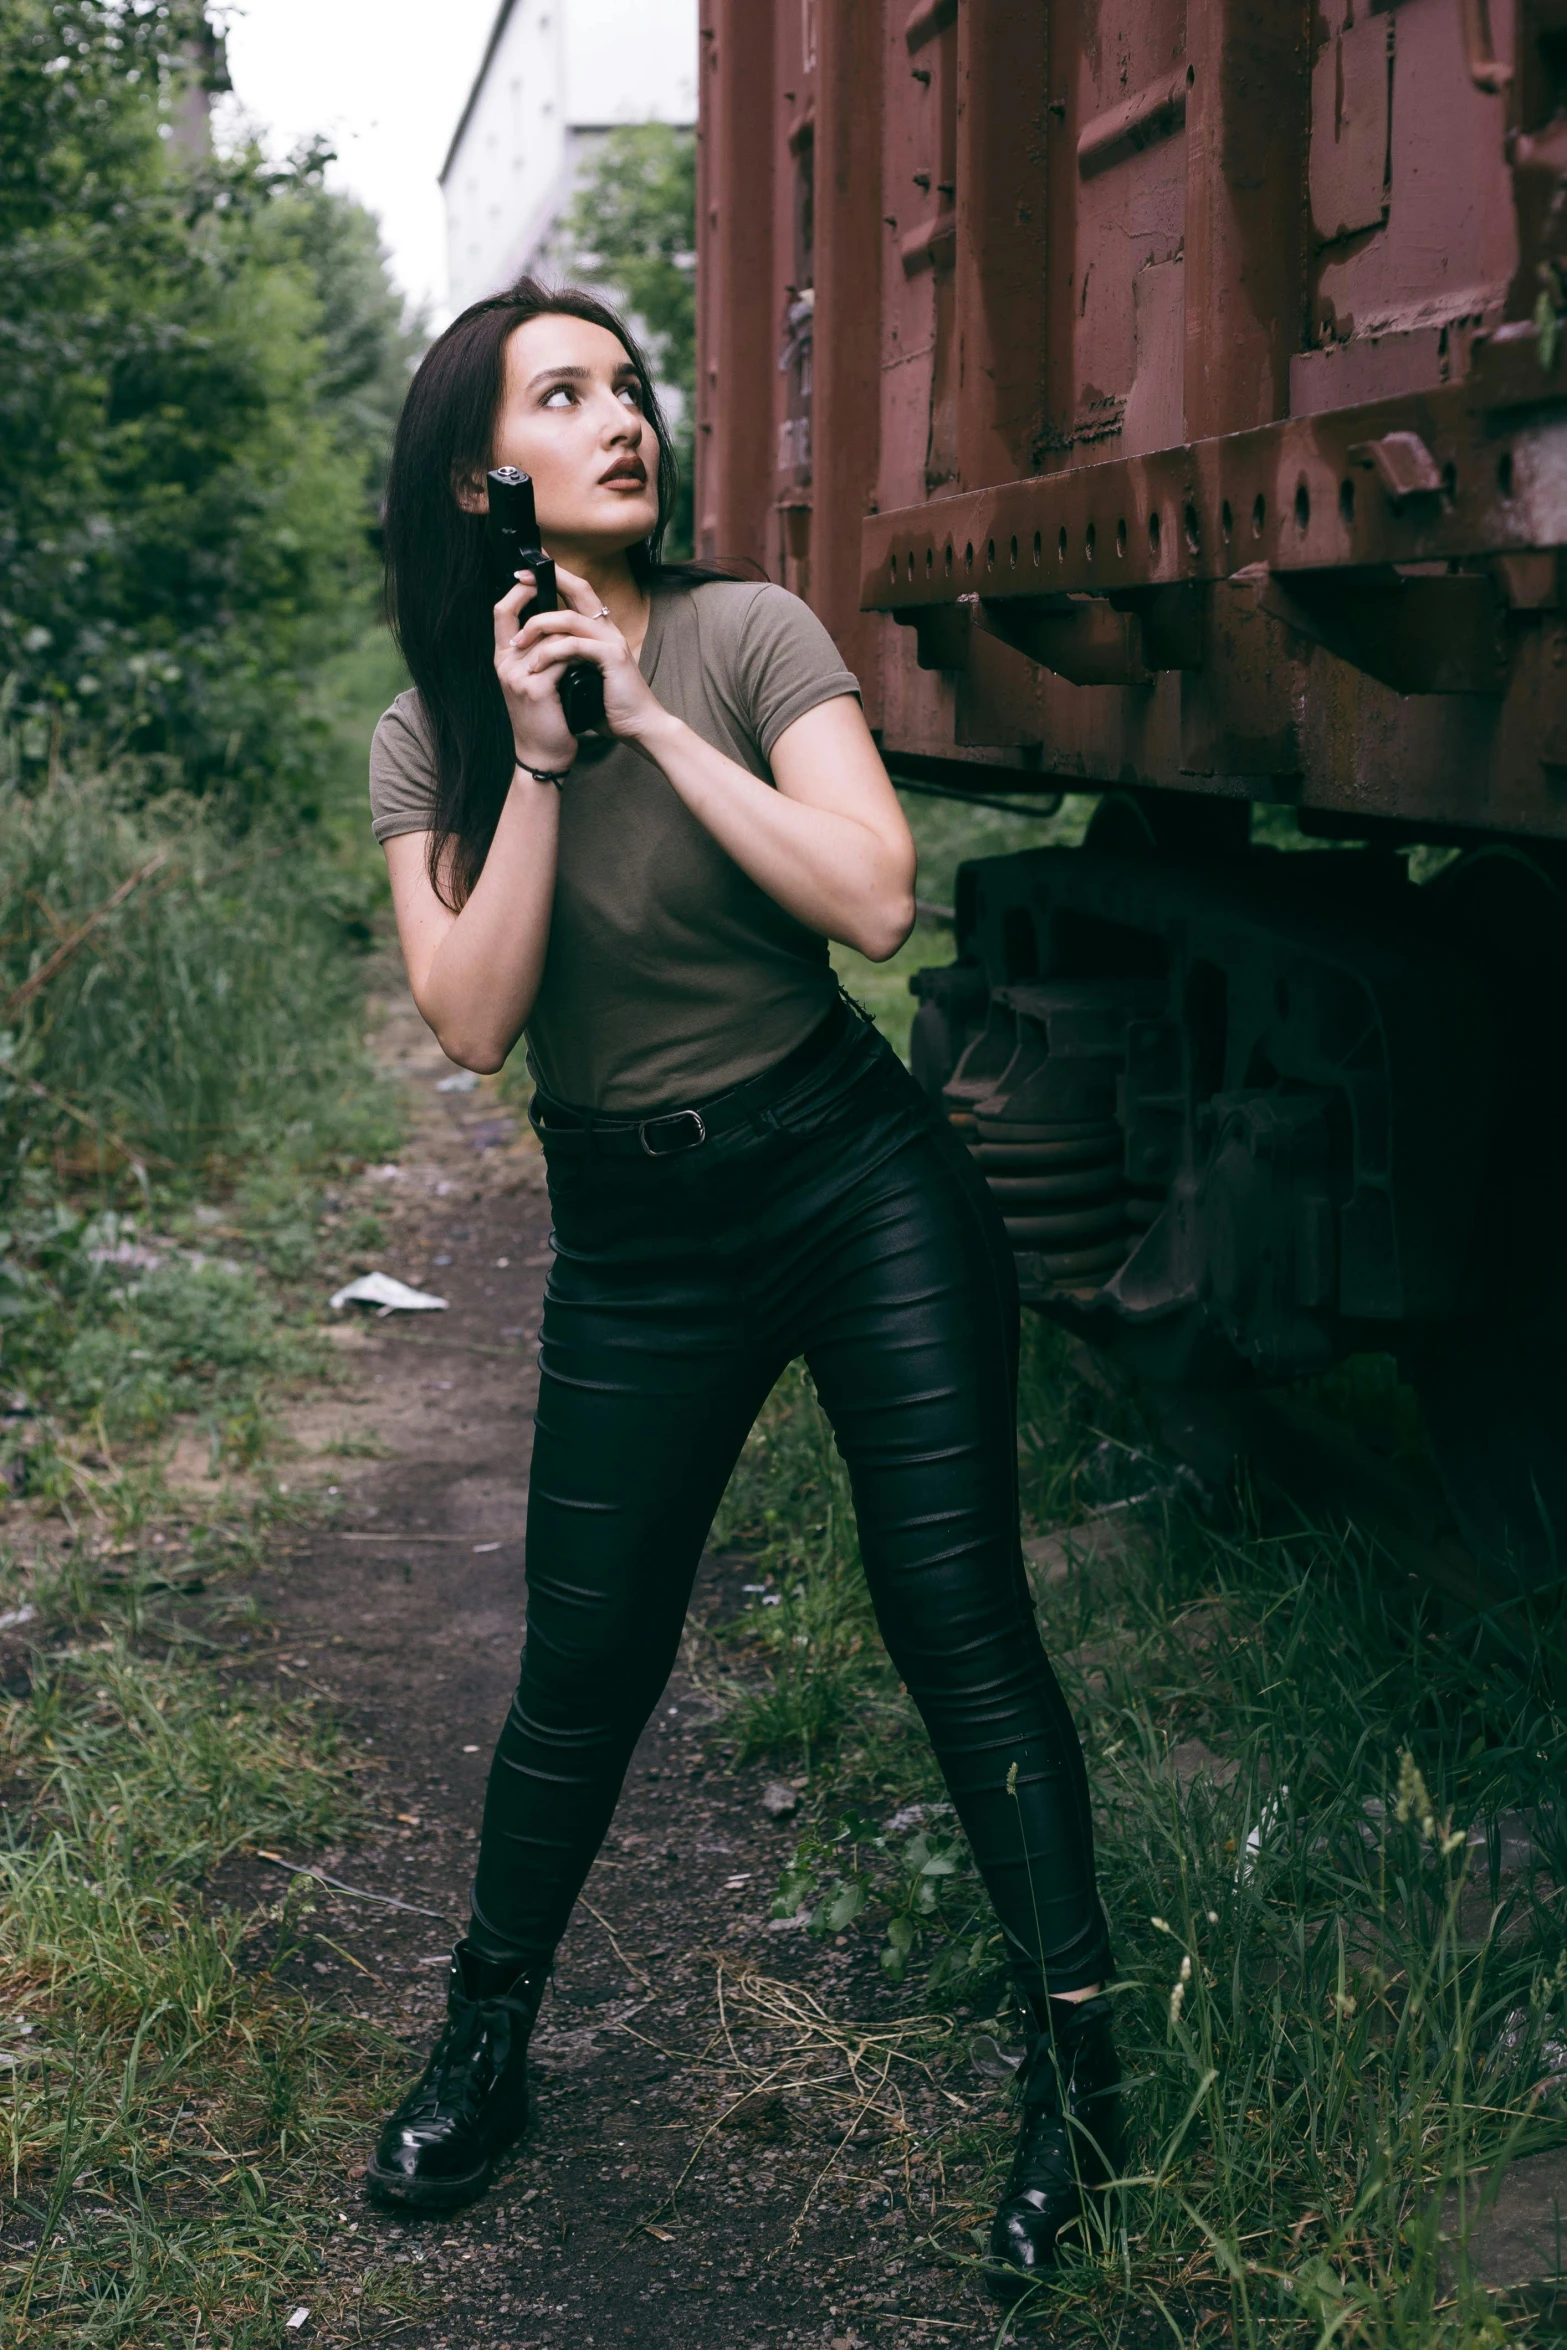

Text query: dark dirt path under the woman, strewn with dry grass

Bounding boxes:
[232,977,1048,2350]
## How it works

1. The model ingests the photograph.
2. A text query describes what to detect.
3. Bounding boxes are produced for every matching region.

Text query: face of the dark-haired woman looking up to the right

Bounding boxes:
[491,315,658,559]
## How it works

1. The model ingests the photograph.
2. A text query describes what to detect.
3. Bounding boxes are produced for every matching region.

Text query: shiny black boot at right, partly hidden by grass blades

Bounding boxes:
[989,1995,1123,2294]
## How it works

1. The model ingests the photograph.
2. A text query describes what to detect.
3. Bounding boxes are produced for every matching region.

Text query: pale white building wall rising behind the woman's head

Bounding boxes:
[442,0,698,310]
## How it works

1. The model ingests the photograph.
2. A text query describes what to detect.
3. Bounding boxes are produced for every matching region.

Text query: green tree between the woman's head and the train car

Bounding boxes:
[552,122,695,557]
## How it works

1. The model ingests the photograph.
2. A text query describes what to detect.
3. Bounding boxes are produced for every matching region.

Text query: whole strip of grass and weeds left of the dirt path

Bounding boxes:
[0,635,422,2350]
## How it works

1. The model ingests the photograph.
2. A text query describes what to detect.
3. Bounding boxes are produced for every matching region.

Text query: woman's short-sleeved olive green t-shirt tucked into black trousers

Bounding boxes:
[369,580,860,1116]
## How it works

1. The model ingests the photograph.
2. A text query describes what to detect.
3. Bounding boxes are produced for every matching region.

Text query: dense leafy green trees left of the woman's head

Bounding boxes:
[0,0,409,813]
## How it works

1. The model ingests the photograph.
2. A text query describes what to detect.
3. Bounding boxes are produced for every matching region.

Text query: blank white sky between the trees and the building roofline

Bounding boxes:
[214,0,498,313]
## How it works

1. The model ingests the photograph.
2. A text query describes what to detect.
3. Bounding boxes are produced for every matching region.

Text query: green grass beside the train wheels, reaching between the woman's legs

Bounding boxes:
[724,1325,1567,2350]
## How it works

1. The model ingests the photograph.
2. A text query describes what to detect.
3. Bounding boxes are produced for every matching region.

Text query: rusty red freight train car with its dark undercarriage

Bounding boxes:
[698,0,1567,1586]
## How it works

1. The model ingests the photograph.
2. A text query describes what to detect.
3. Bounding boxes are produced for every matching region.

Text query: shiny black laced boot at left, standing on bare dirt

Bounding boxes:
[364,1941,545,2211]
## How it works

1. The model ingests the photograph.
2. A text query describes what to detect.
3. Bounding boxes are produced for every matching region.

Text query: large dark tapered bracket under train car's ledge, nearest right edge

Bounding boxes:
[1229,564,1508,693]
